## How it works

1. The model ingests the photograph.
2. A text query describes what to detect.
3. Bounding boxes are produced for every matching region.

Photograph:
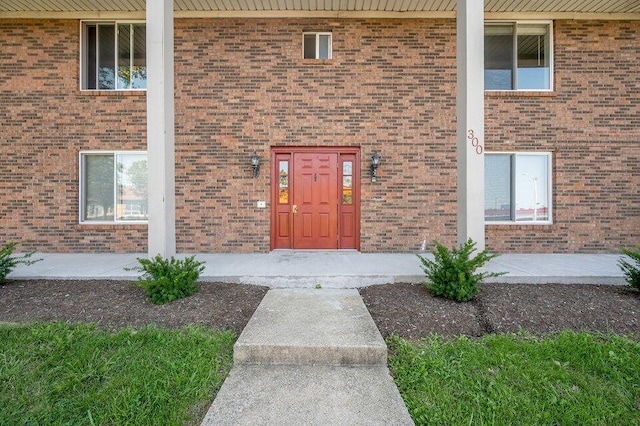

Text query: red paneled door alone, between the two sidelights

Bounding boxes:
[292,152,338,249]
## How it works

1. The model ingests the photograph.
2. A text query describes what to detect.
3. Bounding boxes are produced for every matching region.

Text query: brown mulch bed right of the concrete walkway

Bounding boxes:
[360,284,640,340]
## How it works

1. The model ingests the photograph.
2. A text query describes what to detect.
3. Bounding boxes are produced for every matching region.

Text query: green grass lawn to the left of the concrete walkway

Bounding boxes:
[0,323,236,425]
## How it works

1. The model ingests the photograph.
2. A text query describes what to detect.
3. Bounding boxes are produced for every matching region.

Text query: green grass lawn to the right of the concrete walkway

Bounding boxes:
[388,332,640,425]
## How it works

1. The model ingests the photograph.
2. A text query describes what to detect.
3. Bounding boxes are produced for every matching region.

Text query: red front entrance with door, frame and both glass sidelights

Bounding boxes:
[271,148,360,249]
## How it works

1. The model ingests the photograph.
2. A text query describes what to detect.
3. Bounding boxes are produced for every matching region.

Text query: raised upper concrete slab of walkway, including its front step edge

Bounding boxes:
[234,289,387,366]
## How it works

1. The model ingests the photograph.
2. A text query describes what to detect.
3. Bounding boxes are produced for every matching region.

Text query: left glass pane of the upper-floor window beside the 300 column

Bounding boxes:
[484,25,513,90]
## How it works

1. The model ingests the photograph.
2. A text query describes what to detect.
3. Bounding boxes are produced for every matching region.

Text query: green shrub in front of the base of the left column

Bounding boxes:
[132,255,204,305]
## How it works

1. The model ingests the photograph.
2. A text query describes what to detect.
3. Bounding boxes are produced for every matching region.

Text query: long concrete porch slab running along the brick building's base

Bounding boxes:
[8,250,625,288]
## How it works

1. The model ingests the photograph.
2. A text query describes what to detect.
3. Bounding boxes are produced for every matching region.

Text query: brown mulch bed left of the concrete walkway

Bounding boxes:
[0,280,267,334]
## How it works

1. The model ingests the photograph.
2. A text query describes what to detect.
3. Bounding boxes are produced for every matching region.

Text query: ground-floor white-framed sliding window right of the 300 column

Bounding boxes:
[484,152,551,223]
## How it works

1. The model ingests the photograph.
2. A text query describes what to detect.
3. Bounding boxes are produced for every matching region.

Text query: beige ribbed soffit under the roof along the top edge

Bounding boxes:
[0,0,640,19]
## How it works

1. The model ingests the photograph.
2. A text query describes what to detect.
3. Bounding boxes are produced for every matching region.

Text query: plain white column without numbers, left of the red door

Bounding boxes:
[146,0,176,257]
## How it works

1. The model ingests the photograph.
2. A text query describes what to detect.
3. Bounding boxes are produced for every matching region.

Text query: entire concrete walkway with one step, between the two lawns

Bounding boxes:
[202,289,413,426]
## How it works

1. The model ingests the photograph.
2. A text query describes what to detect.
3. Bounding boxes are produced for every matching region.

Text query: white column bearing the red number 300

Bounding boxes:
[457,0,485,250]
